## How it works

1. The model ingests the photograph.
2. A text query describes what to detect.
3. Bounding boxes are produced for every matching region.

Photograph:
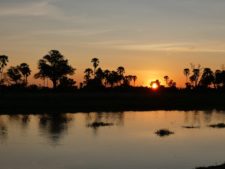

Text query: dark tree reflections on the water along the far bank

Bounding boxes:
[0,110,225,144]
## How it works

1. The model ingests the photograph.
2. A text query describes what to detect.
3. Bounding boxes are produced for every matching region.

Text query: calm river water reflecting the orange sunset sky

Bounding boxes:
[0,111,225,169]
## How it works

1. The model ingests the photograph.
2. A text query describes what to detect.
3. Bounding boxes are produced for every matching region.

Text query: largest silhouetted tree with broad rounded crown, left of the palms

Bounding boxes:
[35,50,75,89]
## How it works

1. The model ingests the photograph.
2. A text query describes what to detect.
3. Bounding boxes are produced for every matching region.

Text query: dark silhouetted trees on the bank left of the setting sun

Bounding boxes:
[0,50,137,89]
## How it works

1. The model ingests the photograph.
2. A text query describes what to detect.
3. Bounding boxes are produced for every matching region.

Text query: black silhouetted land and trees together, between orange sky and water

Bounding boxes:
[0,50,225,113]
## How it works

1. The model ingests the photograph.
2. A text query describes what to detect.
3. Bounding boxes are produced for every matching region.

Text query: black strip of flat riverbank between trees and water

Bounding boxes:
[0,92,225,114]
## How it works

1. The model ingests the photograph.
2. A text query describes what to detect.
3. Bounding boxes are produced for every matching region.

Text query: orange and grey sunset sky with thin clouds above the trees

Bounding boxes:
[0,0,225,86]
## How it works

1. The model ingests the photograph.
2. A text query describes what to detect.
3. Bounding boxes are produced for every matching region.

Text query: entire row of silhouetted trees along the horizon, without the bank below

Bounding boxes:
[0,50,225,89]
